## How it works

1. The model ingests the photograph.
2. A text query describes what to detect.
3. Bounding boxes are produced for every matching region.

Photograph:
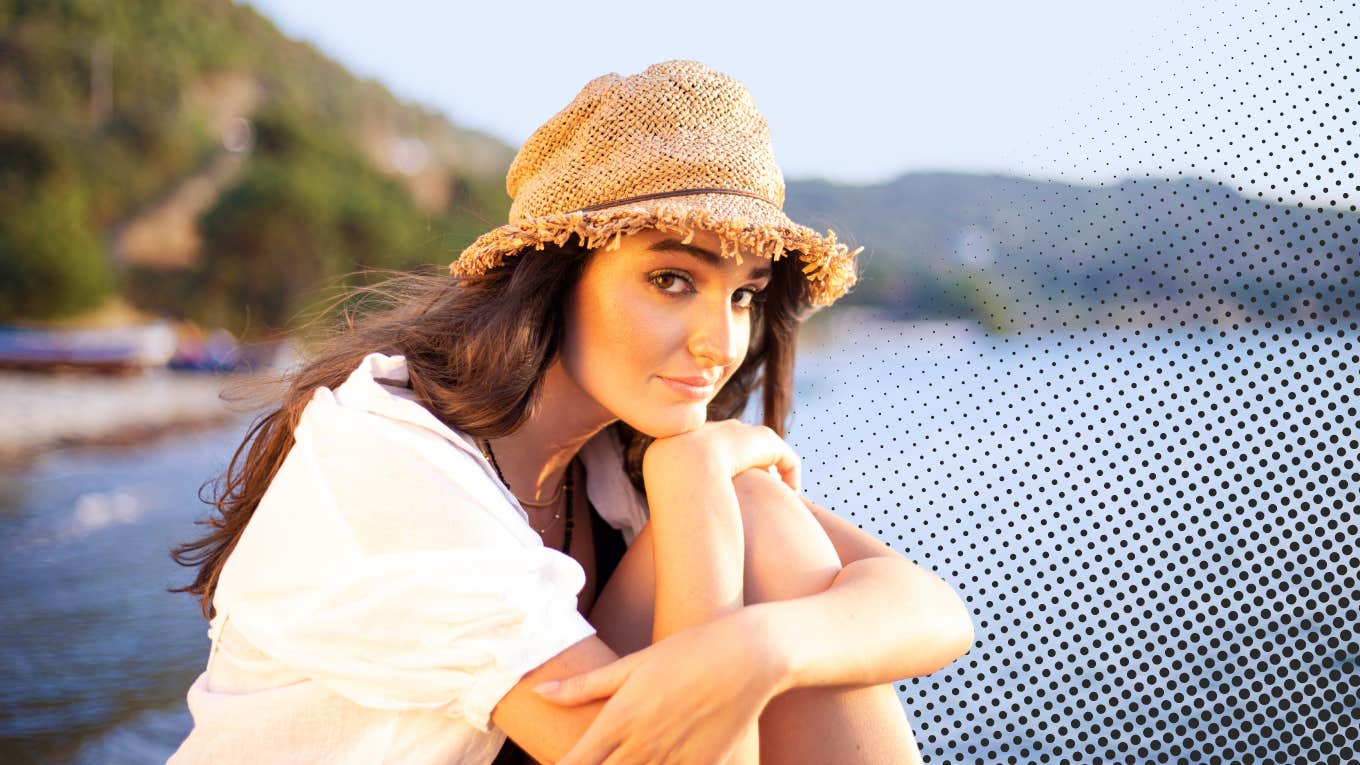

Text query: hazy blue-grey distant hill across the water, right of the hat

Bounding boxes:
[785,173,1360,329]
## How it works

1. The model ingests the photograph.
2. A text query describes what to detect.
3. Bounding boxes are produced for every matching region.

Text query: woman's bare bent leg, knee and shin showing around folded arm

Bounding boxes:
[734,474,921,765]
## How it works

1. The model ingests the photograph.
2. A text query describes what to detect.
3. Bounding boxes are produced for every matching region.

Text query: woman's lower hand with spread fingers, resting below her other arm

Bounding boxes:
[536,611,785,765]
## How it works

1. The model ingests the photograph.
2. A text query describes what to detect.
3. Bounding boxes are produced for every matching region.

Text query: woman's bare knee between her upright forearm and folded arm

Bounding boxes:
[733,470,840,604]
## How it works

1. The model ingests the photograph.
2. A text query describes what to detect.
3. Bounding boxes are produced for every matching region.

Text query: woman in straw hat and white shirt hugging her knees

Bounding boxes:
[173,61,972,765]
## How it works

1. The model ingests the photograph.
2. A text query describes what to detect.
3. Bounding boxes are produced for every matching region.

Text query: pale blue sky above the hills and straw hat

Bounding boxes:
[249,0,1355,205]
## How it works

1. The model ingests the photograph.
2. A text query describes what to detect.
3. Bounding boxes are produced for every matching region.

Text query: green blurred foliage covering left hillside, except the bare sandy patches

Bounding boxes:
[0,0,511,332]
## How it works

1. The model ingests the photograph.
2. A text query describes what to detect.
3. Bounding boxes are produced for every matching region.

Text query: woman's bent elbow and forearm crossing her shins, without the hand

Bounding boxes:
[743,557,972,693]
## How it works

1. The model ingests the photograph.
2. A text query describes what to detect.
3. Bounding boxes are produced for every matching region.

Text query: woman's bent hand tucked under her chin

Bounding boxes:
[642,419,802,491]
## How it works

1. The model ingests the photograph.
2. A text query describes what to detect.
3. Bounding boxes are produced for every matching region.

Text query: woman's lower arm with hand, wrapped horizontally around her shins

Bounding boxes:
[530,552,971,765]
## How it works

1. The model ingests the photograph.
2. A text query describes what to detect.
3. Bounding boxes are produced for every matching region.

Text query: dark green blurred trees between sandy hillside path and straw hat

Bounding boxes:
[159,102,446,331]
